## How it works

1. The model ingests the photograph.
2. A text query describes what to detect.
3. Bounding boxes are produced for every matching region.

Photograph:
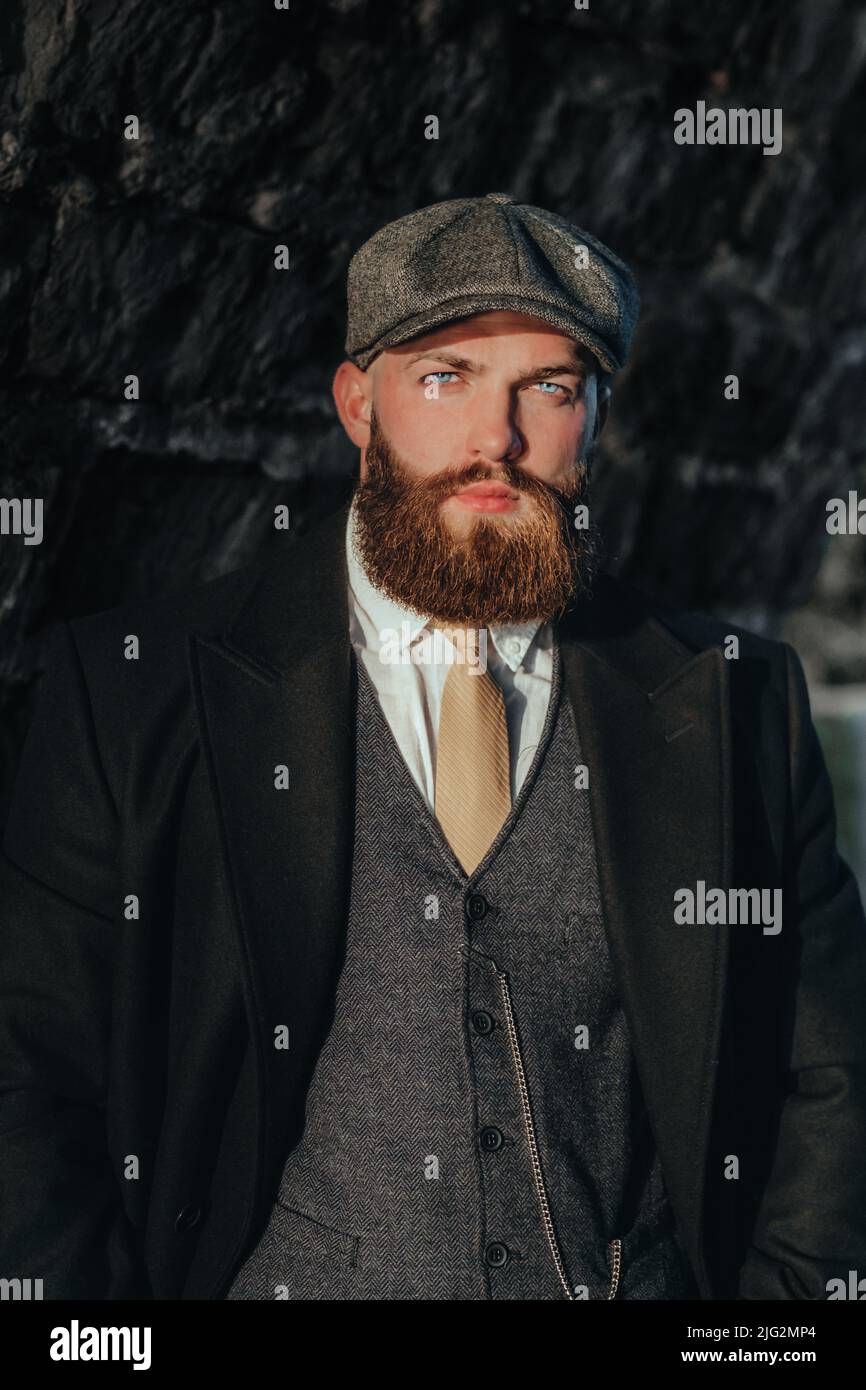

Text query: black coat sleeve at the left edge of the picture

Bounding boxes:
[0,623,152,1300]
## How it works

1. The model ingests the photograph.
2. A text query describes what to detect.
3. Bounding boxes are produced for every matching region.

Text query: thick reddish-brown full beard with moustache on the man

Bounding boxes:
[348,413,599,626]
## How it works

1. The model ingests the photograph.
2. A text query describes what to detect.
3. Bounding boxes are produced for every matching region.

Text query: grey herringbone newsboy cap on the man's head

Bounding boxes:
[346,193,639,373]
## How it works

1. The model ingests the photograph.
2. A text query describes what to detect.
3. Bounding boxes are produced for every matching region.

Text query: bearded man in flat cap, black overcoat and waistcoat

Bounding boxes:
[0,193,866,1301]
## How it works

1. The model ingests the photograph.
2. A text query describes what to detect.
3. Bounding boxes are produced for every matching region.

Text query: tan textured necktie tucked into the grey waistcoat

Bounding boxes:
[434,623,512,874]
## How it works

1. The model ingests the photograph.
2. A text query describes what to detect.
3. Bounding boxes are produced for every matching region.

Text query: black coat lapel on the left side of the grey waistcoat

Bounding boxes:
[189,506,354,1217]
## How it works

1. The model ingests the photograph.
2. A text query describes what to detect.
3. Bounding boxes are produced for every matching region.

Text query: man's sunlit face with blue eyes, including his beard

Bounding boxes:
[334,311,606,626]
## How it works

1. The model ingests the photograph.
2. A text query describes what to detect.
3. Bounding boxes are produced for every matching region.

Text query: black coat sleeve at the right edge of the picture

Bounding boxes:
[738,642,866,1298]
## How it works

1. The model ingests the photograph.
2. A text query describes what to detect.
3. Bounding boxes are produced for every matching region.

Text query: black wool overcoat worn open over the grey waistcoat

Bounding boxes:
[0,506,866,1298]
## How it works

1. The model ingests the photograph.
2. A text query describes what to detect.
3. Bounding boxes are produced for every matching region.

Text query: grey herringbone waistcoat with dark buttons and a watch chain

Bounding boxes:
[227,644,698,1300]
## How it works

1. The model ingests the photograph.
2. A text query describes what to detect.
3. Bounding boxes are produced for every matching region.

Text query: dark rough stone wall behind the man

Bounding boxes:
[0,0,866,811]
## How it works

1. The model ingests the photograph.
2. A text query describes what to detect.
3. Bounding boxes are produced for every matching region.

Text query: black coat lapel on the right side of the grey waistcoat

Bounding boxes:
[559,577,733,1297]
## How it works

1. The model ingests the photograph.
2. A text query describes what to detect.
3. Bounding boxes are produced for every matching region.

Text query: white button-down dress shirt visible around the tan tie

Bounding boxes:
[346,503,553,810]
